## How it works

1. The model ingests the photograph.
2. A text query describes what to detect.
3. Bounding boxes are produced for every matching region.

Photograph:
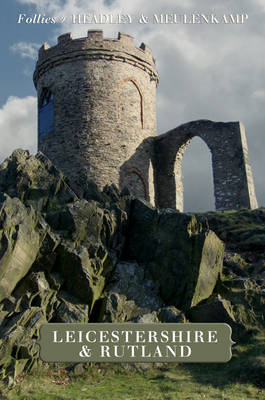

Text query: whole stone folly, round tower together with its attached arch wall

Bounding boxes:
[34,30,258,211]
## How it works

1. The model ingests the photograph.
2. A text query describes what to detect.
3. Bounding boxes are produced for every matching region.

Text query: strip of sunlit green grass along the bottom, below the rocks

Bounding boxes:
[0,336,265,400]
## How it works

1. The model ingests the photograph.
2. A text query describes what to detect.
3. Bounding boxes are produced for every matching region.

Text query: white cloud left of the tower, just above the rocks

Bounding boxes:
[0,96,37,161]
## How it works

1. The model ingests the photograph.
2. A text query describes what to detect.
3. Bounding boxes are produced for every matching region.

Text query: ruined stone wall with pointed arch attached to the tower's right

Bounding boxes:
[155,120,258,211]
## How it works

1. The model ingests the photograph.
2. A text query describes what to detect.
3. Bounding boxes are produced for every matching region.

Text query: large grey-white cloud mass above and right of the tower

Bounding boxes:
[13,0,265,209]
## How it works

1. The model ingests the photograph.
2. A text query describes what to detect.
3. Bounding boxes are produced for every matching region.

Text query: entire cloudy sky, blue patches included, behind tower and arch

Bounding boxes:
[0,0,265,211]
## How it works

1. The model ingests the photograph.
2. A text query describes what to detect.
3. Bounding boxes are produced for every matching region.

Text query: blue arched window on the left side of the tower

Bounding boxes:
[39,89,54,139]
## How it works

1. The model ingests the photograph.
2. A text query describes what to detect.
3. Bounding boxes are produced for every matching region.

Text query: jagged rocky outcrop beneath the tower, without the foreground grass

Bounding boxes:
[0,150,265,376]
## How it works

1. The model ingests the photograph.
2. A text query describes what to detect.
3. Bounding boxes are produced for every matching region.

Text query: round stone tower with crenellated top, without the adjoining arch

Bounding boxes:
[34,30,158,200]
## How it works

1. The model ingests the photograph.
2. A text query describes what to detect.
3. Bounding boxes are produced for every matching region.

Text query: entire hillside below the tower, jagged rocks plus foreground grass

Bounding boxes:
[0,150,265,390]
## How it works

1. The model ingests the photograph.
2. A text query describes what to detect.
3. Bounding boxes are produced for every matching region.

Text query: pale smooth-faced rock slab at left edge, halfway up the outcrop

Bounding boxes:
[0,193,48,301]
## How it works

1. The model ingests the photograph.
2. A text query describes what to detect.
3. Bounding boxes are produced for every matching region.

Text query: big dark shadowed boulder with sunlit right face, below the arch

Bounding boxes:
[125,200,224,309]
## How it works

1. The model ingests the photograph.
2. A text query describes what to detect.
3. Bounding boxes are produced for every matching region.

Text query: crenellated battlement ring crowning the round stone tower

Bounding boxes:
[34,30,158,86]
